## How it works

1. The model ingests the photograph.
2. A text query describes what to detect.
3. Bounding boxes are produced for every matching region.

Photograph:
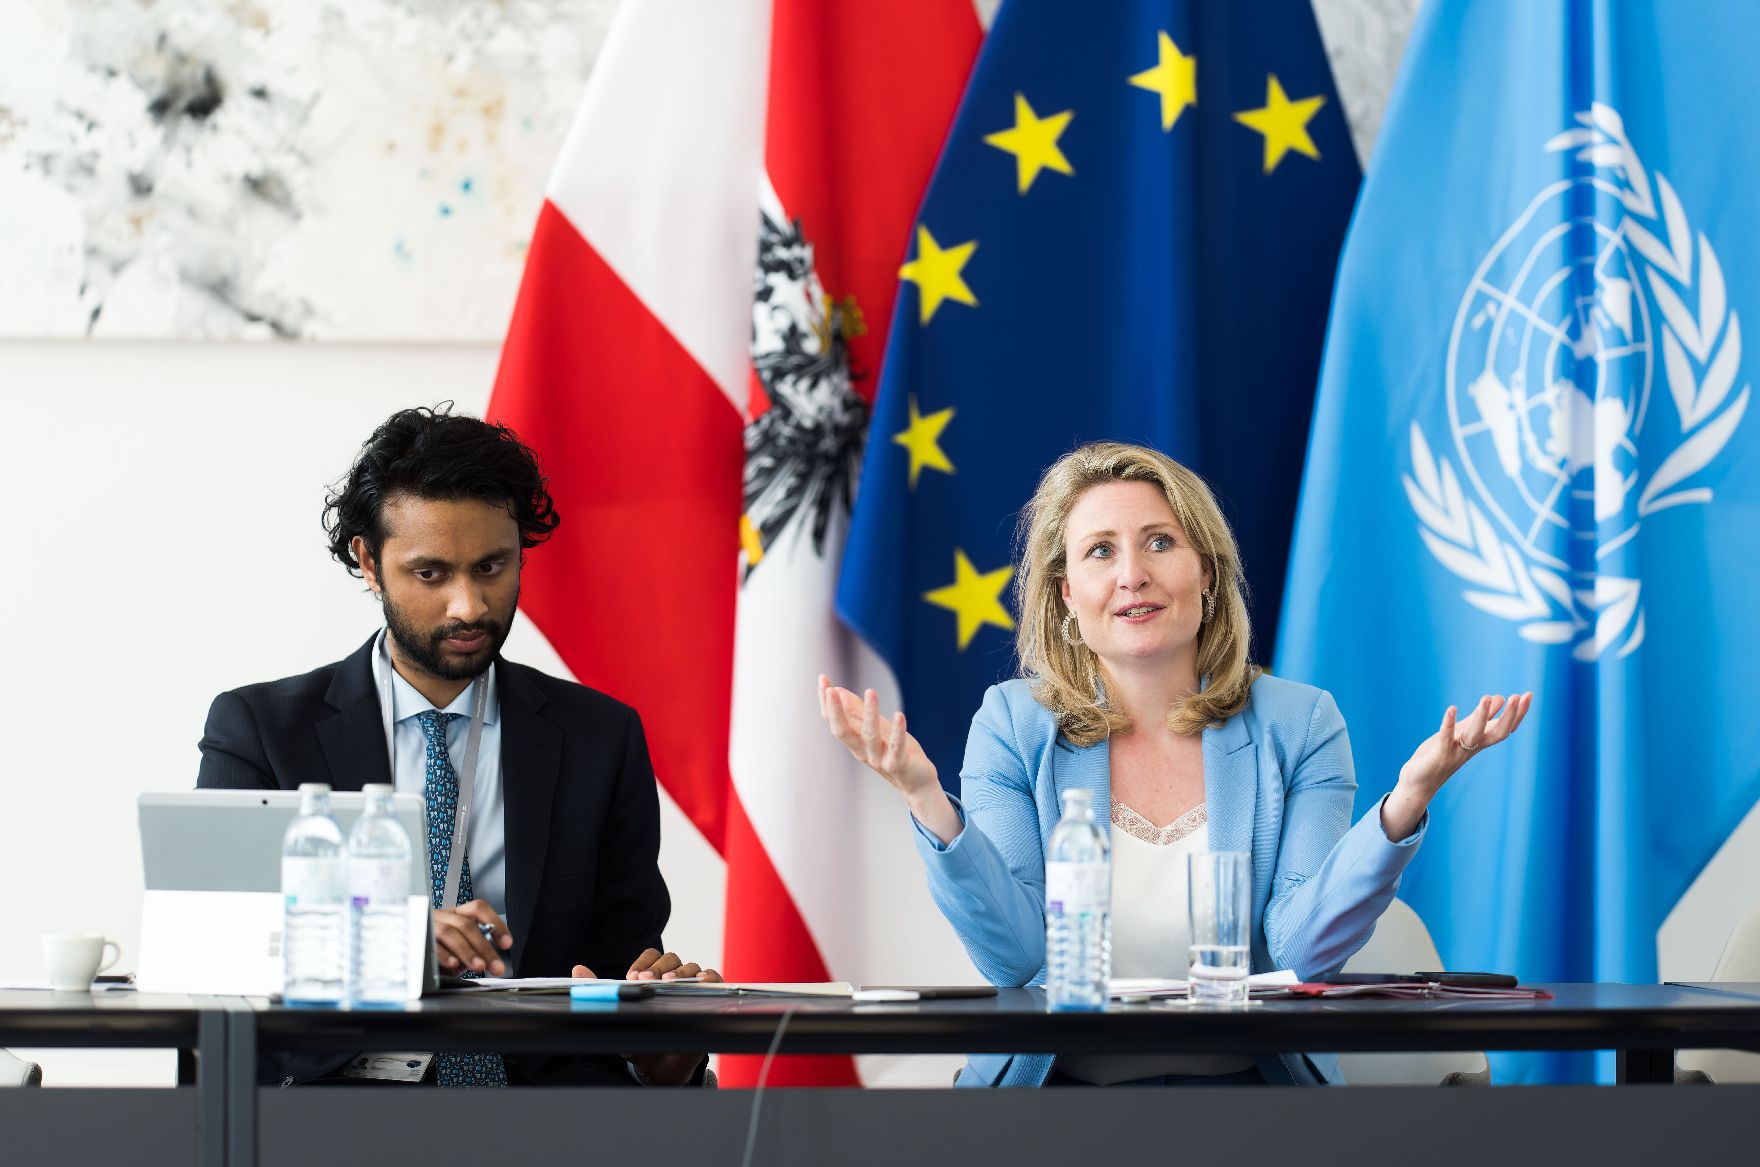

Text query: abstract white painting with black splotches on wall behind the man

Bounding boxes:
[0,0,614,341]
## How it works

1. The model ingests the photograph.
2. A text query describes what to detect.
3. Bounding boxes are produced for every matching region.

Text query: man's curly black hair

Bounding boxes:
[324,401,561,576]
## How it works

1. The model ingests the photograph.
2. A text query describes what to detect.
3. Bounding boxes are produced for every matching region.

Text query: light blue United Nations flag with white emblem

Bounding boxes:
[1278,0,1760,1081]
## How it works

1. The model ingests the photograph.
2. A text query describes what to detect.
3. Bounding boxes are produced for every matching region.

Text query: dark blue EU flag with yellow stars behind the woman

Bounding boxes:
[838,0,1360,789]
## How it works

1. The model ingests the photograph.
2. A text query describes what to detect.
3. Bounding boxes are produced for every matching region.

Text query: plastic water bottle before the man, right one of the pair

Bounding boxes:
[348,785,412,1005]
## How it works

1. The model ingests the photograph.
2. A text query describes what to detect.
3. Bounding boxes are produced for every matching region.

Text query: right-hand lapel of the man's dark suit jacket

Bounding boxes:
[496,660,559,975]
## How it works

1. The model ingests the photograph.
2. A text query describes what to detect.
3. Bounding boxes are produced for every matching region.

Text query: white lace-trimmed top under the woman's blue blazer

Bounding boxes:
[1058,799,1253,1084]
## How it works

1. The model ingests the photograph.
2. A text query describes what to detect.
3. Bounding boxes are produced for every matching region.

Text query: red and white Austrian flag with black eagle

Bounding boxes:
[489,0,980,1084]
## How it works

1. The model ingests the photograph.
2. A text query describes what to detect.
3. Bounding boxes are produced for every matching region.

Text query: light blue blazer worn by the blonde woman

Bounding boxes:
[917,676,1429,1086]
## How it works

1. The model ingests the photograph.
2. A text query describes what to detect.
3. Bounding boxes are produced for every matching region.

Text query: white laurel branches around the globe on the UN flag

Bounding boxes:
[1403,102,1749,660]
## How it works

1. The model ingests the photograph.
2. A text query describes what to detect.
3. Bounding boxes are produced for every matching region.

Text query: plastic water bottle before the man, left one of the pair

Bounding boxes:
[282,782,348,1005]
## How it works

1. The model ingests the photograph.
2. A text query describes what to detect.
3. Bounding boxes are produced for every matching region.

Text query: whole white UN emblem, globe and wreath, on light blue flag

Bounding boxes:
[1401,102,1749,660]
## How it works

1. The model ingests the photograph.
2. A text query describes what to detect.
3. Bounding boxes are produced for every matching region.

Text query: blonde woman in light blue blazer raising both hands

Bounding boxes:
[818,442,1533,1086]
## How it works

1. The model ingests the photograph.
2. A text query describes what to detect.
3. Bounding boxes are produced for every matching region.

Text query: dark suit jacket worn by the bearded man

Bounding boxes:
[195,641,672,1084]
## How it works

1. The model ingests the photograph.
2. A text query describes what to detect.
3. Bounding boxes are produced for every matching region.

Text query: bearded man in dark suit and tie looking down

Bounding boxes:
[197,407,718,1086]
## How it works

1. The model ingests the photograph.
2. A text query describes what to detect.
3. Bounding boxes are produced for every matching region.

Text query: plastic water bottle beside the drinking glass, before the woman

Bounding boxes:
[1045,790,1112,1009]
